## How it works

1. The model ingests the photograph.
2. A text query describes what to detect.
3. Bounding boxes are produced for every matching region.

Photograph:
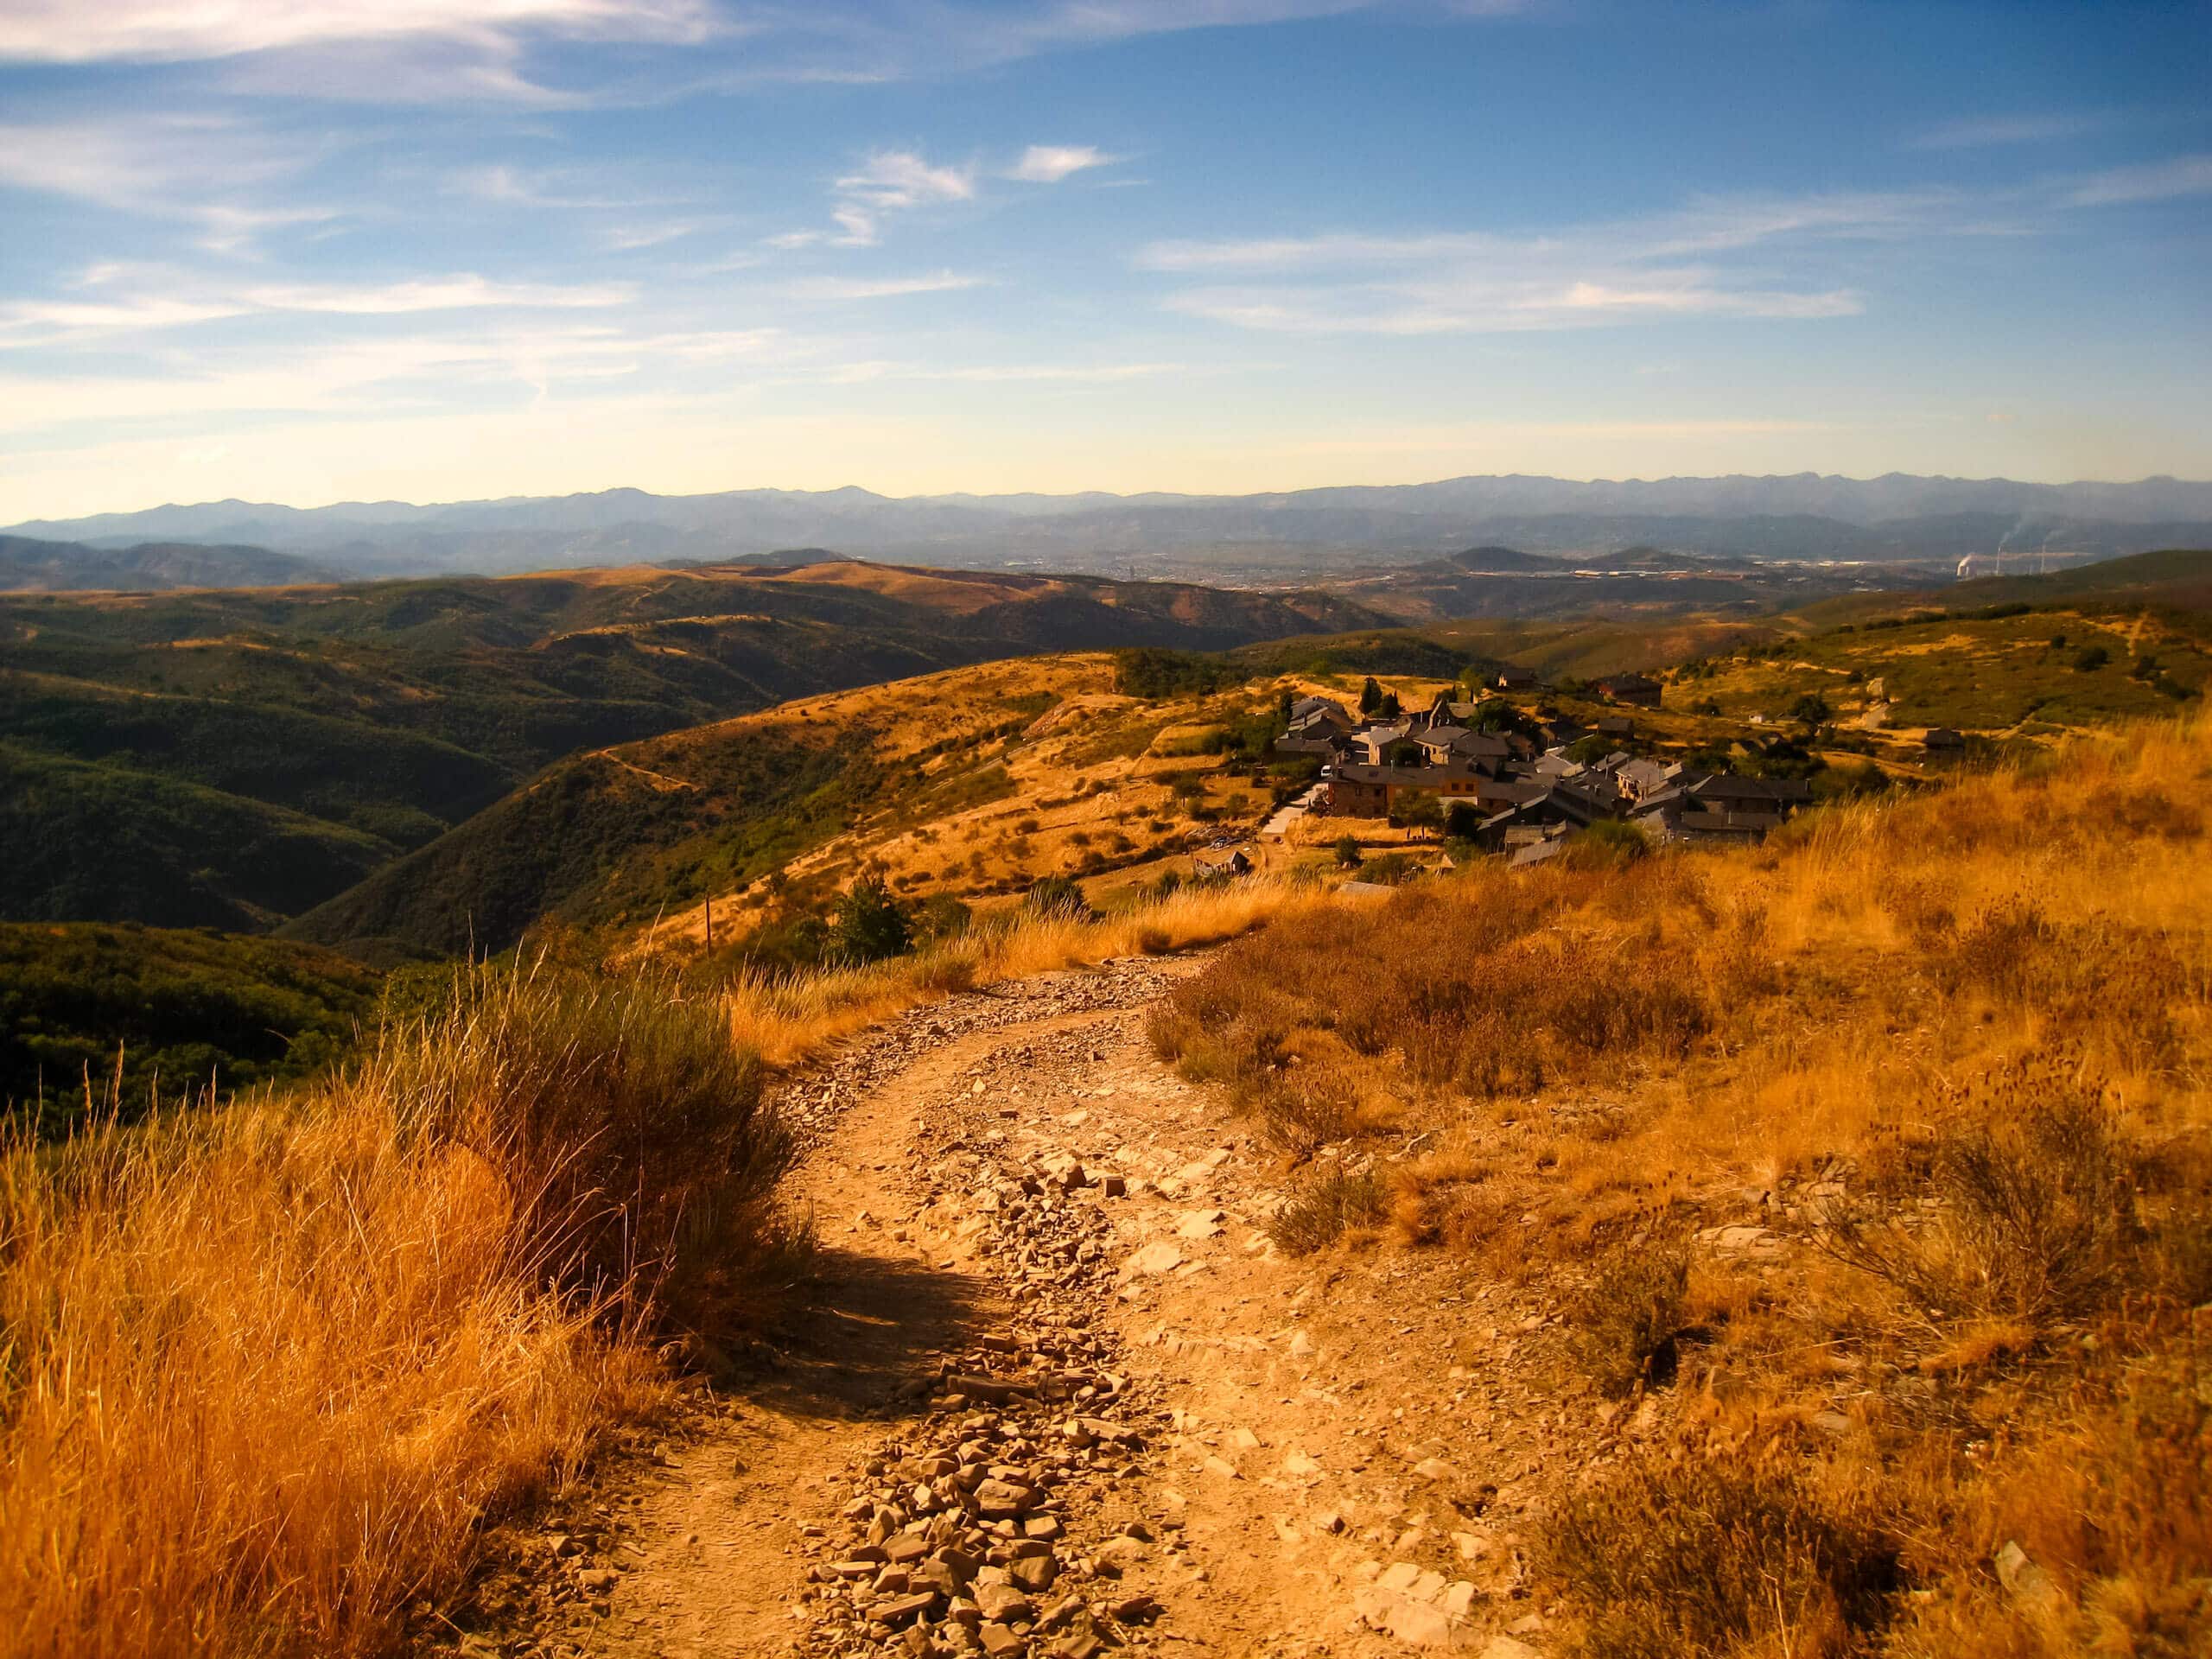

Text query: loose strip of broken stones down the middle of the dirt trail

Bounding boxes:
[798,1039,1181,1659]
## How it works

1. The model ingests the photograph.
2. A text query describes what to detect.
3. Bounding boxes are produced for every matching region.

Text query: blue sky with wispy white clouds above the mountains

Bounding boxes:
[0,0,2212,522]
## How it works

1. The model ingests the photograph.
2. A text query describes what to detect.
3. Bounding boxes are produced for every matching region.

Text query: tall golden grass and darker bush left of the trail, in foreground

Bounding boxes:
[0,969,787,1659]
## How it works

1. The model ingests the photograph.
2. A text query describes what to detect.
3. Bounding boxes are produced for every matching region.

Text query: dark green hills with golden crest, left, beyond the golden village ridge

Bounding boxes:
[0,560,1380,929]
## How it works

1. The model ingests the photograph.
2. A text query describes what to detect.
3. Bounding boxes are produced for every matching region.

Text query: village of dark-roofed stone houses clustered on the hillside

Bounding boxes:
[1276,668,1812,862]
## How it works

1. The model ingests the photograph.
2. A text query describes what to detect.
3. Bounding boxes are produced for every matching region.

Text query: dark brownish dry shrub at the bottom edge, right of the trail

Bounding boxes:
[1537,1451,1897,1659]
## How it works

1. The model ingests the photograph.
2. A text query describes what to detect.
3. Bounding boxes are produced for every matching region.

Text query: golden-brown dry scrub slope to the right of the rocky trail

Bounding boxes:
[1153,723,2212,1659]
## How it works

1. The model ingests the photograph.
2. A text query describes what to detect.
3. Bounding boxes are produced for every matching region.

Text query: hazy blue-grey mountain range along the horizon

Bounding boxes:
[13,474,2212,580]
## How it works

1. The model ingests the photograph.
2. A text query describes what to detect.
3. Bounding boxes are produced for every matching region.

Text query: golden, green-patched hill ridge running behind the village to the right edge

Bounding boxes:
[285,562,2212,960]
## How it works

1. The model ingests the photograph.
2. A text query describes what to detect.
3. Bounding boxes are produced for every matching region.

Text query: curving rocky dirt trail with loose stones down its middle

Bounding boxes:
[480,957,1610,1659]
